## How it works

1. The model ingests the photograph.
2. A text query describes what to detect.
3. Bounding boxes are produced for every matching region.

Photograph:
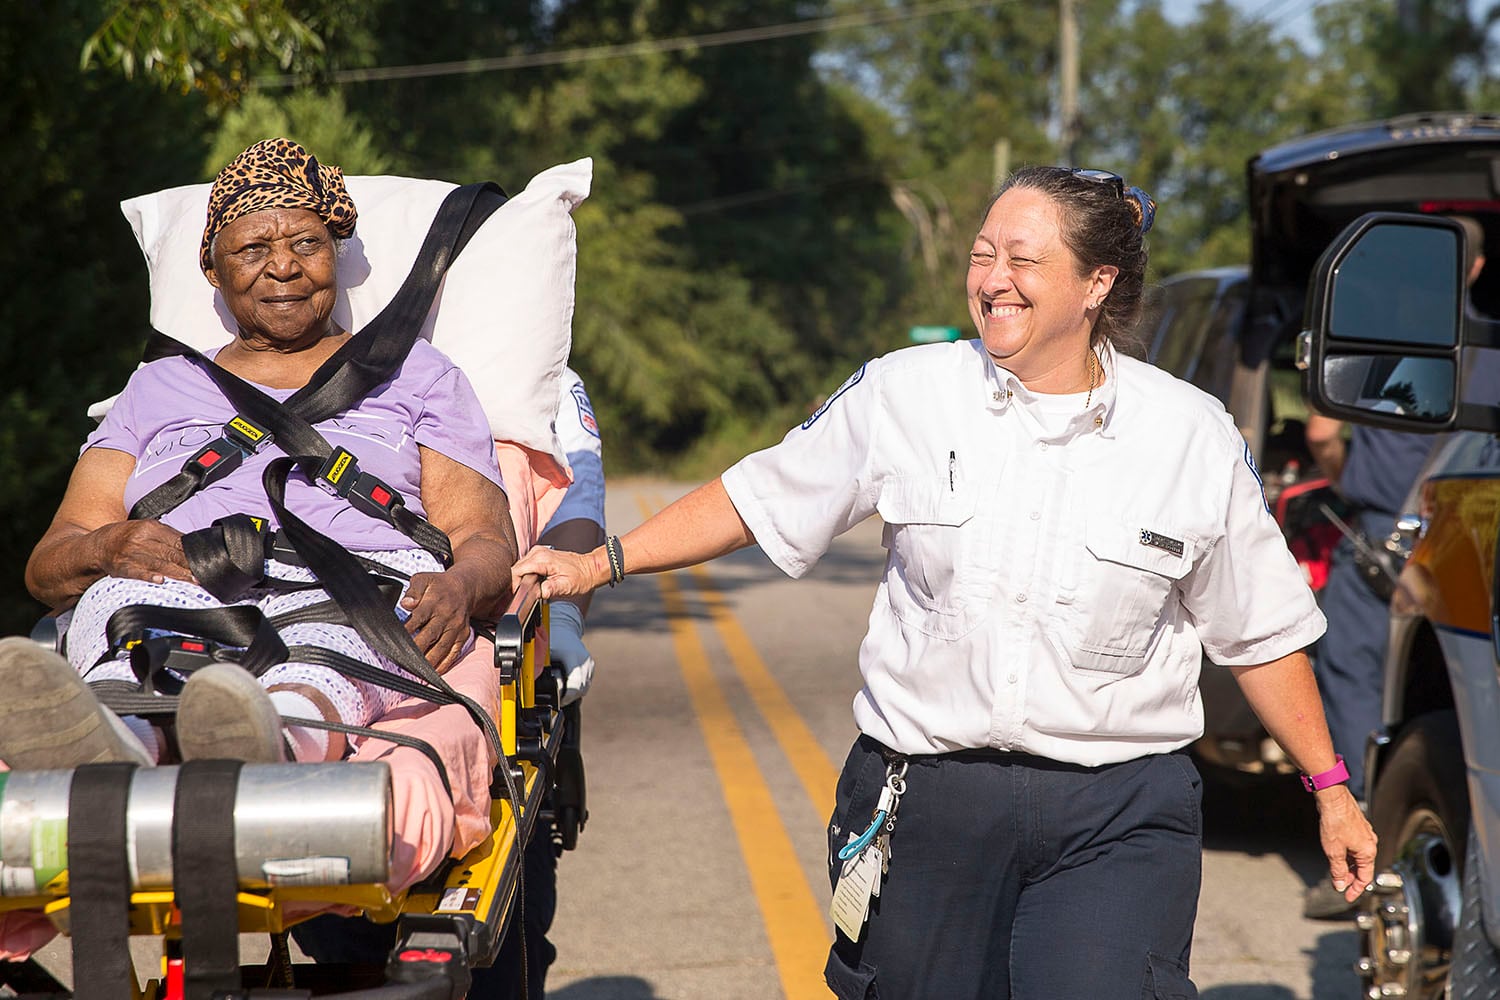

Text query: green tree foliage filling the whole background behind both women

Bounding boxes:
[0,0,1500,631]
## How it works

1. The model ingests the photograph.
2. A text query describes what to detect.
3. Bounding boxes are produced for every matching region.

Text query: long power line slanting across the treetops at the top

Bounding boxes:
[251,0,1013,90]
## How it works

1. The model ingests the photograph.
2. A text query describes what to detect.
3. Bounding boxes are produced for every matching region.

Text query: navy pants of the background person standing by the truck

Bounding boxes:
[1313,511,1395,799]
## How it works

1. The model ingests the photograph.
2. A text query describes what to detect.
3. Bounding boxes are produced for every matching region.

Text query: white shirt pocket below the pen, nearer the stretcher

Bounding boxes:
[875,477,989,639]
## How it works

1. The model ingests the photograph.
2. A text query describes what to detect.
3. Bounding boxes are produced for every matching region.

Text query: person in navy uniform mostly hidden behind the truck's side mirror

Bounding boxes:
[1302,216,1485,919]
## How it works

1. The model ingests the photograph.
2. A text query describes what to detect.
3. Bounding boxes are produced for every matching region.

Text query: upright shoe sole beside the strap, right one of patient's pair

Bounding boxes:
[177,663,287,763]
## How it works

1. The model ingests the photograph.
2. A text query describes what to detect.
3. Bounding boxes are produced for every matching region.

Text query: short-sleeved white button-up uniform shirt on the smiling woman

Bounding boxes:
[723,340,1325,765]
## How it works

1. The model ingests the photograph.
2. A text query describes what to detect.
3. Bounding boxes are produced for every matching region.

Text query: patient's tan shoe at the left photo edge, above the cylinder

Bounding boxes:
[0,636,155,771]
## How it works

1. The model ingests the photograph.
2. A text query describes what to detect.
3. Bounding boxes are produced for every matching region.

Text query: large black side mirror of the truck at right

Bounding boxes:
[1298,213,1464,432]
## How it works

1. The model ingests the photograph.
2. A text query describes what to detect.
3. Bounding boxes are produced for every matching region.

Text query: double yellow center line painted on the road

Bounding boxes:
[636,498,839,1000]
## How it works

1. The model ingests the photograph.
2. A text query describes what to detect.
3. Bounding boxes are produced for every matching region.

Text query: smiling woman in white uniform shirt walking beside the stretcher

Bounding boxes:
[515,166,1376,1000]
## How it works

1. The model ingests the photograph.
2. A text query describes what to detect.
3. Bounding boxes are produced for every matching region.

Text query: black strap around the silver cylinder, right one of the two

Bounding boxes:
[173,760,243,1000]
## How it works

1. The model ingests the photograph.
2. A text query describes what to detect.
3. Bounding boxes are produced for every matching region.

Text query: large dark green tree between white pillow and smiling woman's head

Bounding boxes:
[330,0,905,458]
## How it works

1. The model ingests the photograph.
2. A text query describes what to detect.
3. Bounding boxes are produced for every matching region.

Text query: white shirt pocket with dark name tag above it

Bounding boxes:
[1068,516,1197,675]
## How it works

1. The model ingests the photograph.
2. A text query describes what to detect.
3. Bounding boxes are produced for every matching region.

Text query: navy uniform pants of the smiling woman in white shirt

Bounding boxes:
[825,736,1203,1000]
